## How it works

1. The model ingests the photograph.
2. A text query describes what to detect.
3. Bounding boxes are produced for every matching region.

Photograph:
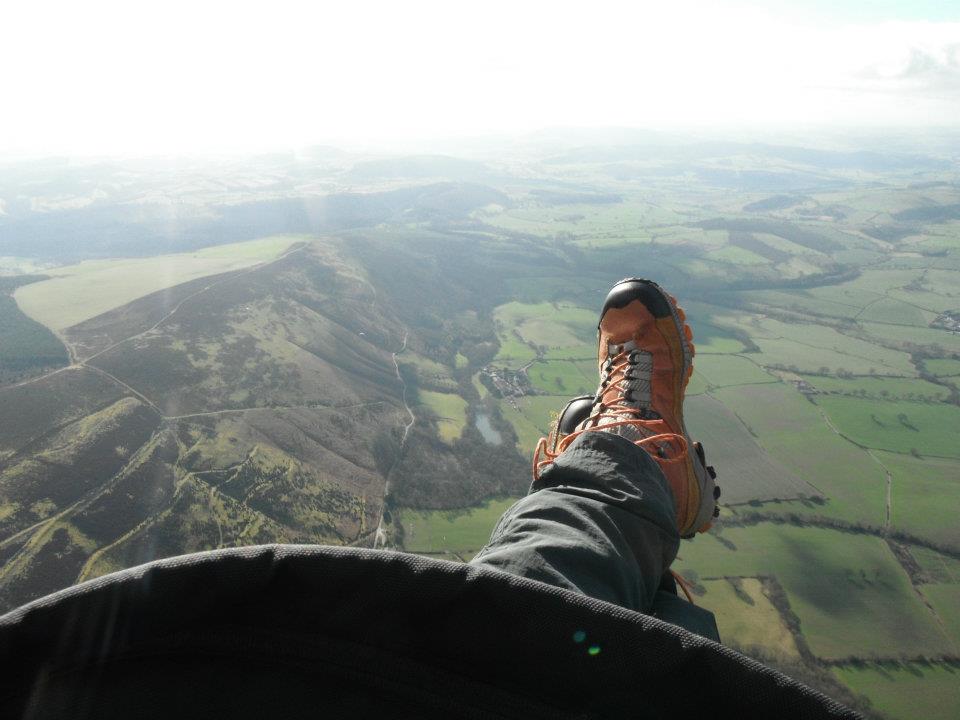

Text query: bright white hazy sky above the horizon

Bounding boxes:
[0,0,960,155]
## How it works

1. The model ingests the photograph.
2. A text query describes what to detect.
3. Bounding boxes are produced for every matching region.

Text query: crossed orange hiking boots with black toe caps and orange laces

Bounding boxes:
[534,278,720,538]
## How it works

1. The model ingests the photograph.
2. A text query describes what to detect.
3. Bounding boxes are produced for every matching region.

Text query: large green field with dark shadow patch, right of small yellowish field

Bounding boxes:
[679,523,953,659]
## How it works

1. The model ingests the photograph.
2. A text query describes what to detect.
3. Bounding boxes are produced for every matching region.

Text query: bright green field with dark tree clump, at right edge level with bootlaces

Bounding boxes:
[817,395,960,458]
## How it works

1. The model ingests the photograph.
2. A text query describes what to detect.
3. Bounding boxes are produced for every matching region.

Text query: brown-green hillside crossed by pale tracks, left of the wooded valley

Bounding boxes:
[0,243,404,608]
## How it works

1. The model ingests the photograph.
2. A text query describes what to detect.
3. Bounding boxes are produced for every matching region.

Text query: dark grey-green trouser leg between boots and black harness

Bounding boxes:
[471,432,717,639]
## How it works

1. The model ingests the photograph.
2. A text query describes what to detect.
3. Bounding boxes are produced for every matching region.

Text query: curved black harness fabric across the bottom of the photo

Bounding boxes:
[0,545,859,718]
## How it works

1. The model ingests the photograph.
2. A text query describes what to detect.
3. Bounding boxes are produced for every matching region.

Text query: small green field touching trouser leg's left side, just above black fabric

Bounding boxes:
[400,498,516,560]
